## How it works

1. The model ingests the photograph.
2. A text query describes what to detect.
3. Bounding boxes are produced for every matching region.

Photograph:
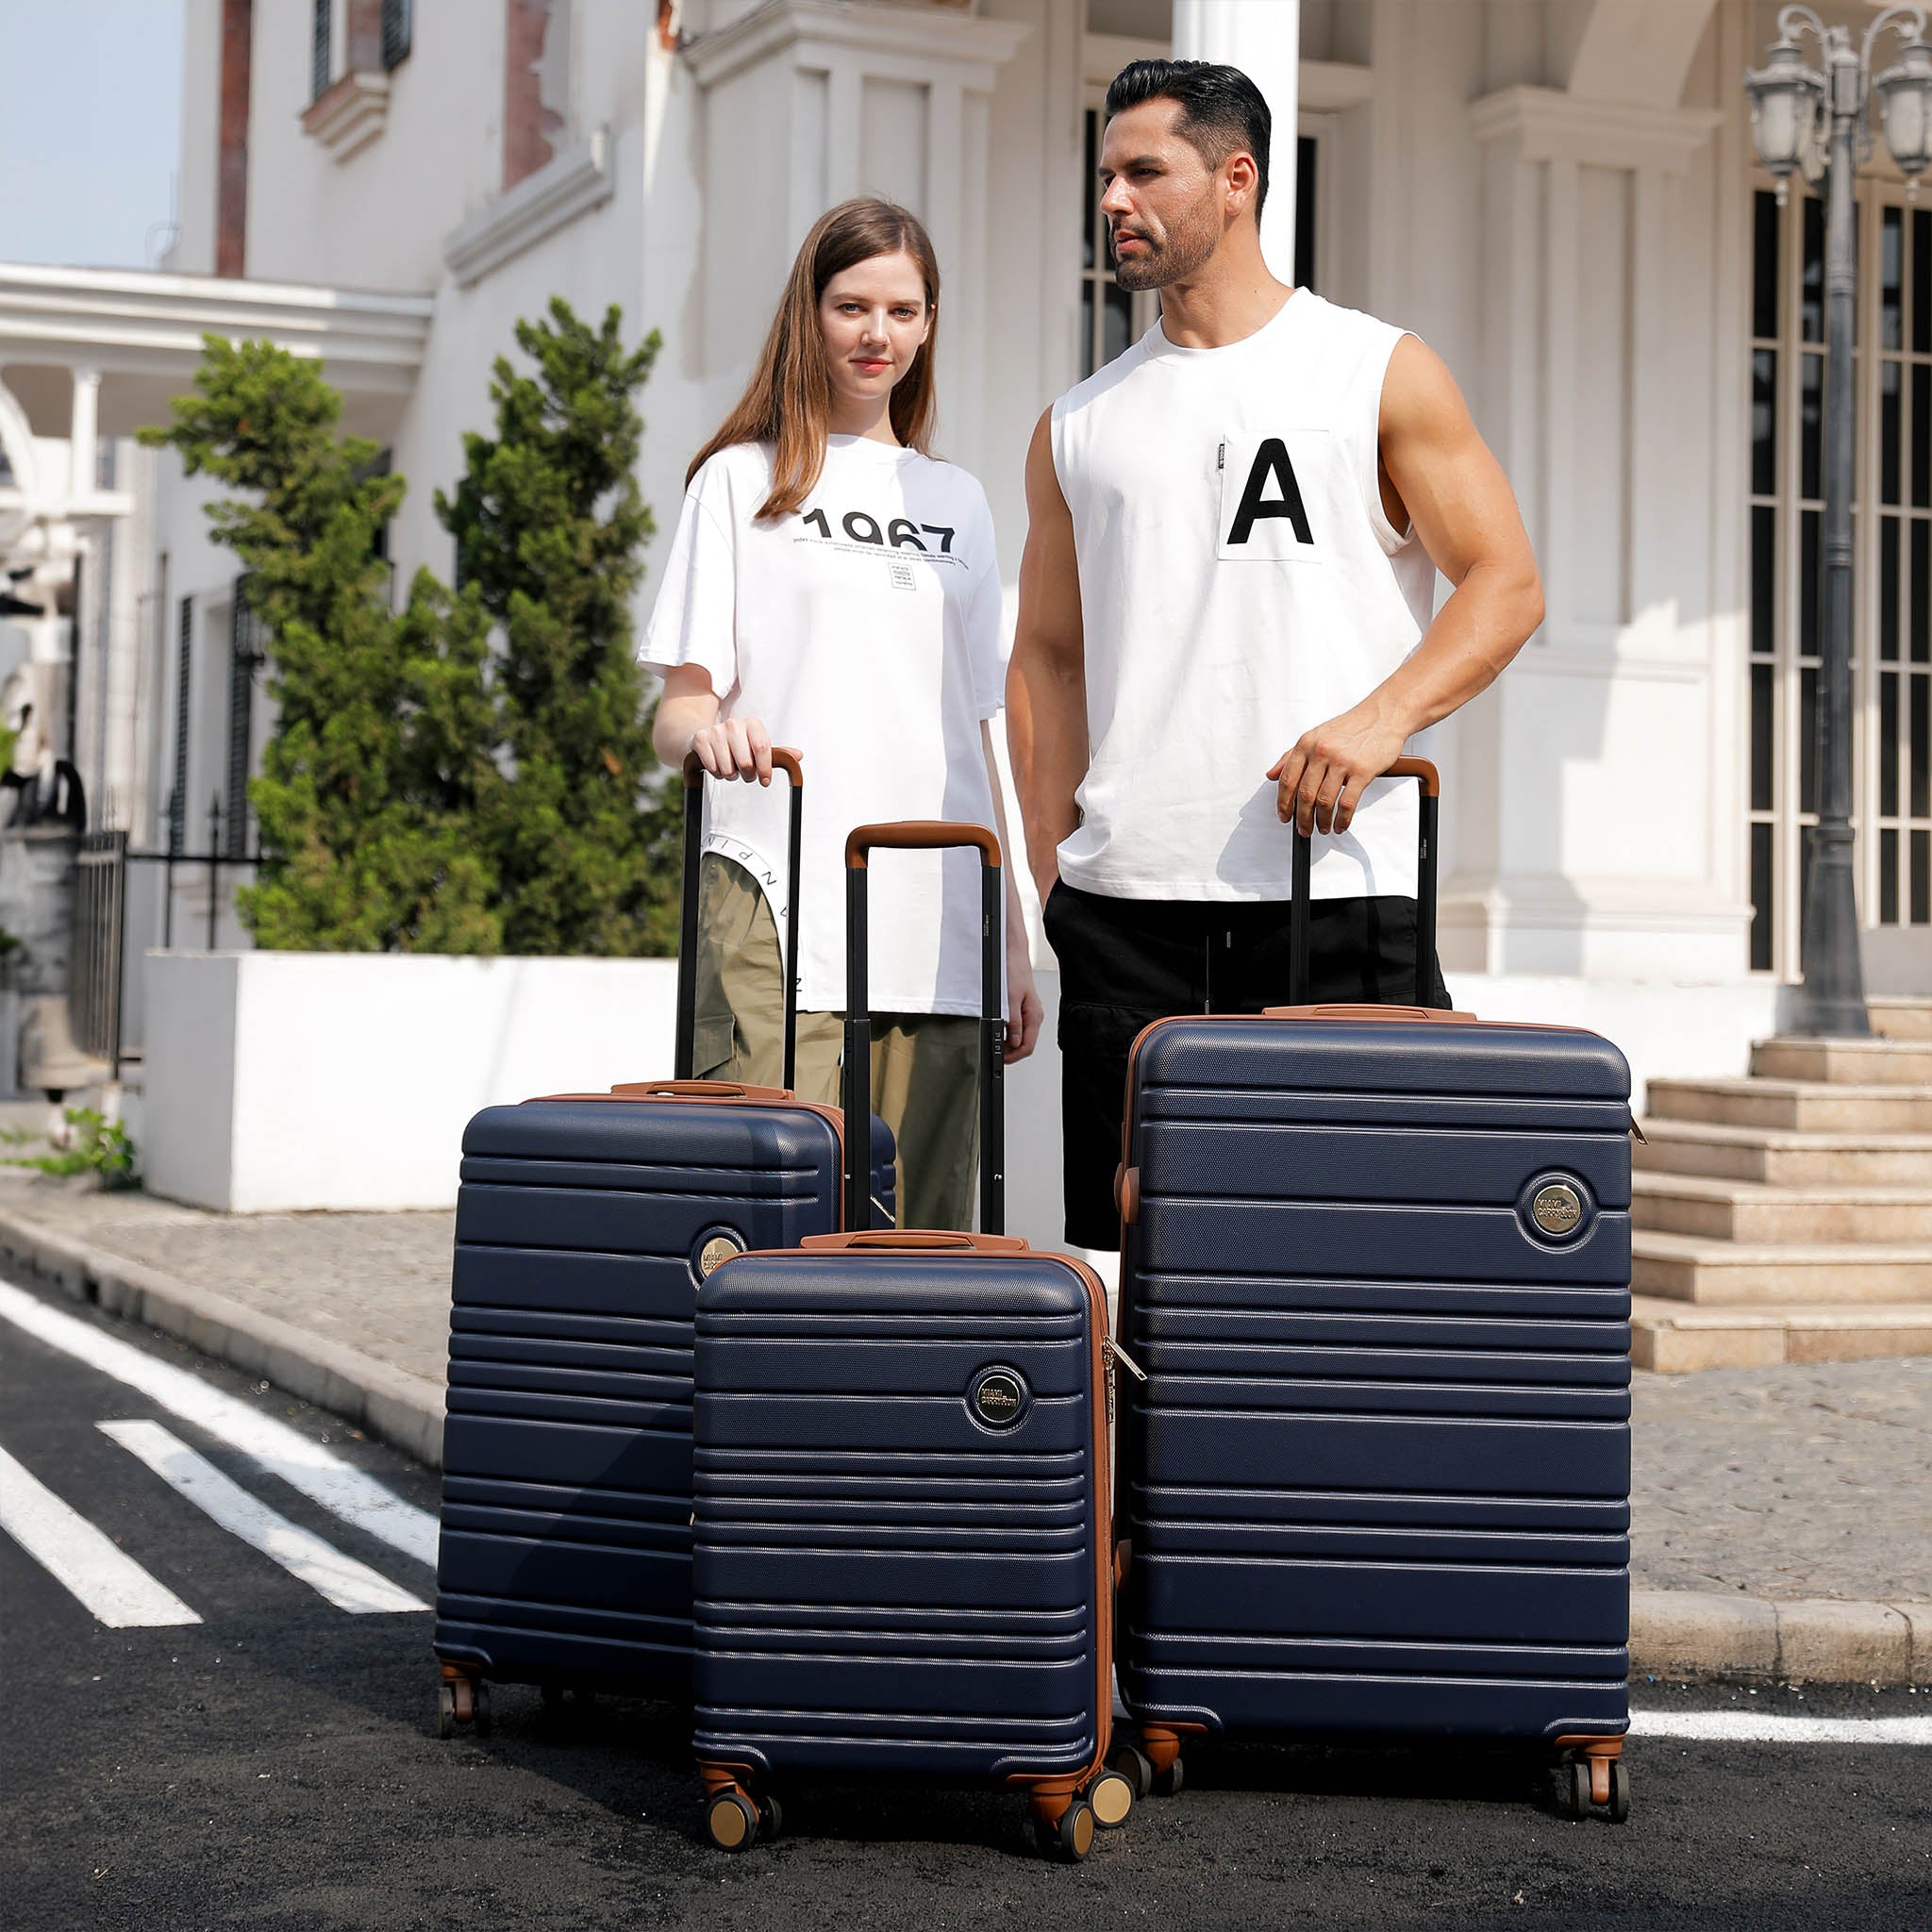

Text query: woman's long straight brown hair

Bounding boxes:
[684,197,939,522]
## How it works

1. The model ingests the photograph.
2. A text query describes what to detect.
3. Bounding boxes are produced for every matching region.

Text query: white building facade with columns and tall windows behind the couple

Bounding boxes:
[15,0,1932,1071]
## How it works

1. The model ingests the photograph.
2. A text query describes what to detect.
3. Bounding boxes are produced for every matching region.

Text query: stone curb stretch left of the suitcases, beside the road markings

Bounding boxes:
[0,1213,441,1460]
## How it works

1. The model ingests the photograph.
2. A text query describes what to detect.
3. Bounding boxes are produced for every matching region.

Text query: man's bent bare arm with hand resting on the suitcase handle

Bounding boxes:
[1267,336,1543,833]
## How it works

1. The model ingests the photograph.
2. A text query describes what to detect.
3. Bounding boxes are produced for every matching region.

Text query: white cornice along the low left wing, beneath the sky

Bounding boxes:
[0,263,431,394]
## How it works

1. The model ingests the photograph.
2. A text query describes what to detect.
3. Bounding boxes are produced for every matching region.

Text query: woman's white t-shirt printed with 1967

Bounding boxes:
[638,437,1005,1014]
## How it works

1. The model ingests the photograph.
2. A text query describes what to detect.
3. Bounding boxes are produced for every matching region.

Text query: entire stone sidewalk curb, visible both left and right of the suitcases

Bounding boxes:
[0,1213,1932,1687]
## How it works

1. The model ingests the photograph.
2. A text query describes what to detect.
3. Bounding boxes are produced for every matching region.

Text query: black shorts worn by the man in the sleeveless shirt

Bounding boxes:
[1041,879,1449,1248]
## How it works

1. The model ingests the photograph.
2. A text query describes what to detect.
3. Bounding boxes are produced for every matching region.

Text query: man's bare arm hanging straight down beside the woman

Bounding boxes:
[1007,411,1088,904]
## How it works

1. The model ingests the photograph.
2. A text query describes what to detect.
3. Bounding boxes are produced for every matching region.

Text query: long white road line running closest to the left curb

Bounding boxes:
[0,1281,437,1569]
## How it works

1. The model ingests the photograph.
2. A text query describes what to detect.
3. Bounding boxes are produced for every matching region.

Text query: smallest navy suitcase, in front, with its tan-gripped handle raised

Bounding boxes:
[691,824,1132,1858]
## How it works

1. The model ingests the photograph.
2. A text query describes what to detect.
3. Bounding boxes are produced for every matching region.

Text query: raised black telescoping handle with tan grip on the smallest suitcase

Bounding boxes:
[841,819,1007,1235]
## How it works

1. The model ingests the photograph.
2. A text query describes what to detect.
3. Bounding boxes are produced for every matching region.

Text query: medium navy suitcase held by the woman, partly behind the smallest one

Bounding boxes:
[433,752,892,1735]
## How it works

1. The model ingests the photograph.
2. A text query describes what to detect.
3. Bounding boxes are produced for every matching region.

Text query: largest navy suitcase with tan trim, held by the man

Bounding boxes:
[1115,759,1631,1818]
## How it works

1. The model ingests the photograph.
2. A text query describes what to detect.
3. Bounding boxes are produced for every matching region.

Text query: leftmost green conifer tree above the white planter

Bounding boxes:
[142,336,502,953]
